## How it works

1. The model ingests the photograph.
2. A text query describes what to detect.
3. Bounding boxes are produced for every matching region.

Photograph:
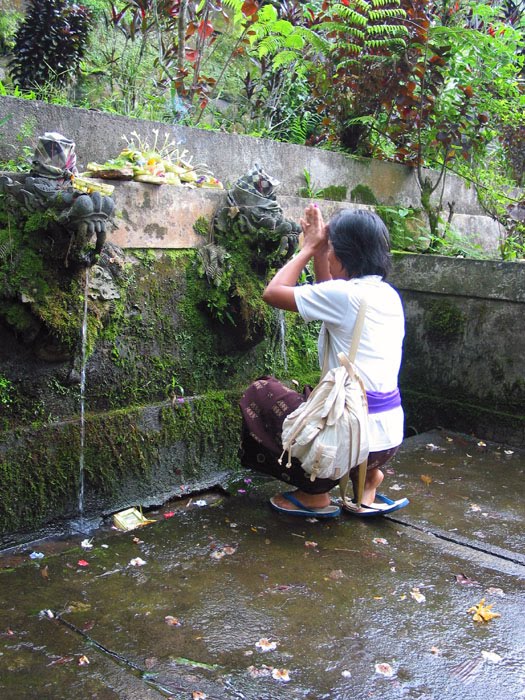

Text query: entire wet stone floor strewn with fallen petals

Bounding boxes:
[0,432,525,700]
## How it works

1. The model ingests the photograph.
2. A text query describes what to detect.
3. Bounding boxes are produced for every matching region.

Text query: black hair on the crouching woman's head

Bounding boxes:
[328,209,392,279]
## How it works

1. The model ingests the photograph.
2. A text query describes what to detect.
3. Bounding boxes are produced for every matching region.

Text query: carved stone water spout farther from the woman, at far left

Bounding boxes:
[0,132,115,269]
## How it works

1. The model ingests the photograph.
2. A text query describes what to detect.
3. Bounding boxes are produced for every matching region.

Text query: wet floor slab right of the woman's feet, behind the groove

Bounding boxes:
[383,431,525,564]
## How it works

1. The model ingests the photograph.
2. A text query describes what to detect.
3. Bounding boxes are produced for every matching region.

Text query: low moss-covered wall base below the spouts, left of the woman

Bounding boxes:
[0,392,240,546]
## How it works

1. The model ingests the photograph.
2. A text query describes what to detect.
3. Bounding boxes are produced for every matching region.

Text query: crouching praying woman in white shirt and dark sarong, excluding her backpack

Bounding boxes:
[241,204,408,518]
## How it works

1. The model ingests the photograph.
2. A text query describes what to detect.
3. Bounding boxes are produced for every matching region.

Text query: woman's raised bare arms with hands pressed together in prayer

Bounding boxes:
[263,204,331,311]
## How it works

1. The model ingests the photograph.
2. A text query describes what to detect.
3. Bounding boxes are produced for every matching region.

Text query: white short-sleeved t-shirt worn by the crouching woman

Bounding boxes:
[294,275,405,452]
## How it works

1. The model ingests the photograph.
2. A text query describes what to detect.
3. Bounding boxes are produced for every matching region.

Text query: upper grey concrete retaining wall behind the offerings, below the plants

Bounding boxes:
[0,97,501,254]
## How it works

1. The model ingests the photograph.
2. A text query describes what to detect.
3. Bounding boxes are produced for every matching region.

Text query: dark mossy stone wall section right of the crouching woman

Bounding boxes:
[391,255,525,447]
